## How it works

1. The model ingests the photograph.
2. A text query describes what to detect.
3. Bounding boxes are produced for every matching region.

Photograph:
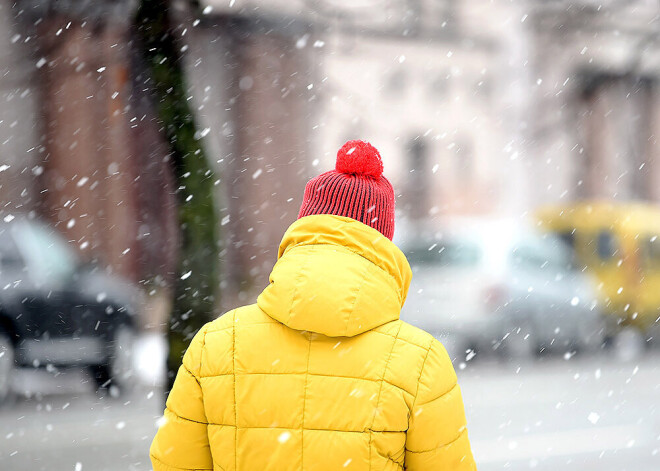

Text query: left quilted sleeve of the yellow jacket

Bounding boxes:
[149,328,213,471]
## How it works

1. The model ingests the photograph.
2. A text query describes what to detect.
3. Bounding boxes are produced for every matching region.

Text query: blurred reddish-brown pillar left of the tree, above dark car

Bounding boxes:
[39,16,138,281]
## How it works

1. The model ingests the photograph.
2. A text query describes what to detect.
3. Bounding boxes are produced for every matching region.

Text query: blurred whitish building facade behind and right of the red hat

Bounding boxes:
[312,0,660,232]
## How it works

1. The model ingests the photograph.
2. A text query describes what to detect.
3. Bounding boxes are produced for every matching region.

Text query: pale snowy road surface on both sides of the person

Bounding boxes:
[0,344,660,471]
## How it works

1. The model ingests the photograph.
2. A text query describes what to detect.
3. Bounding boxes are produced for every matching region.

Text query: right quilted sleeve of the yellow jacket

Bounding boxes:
[405,339,476,471]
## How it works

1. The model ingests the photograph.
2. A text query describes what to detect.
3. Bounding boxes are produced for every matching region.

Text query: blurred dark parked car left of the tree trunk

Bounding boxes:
[0,219,140,402]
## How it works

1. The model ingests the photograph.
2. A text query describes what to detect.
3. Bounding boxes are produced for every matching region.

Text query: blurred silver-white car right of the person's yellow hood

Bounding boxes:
[401,221,605,359]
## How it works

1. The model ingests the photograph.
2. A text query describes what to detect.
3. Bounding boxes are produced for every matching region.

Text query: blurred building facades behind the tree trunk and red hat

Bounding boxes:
[0,0,660,314]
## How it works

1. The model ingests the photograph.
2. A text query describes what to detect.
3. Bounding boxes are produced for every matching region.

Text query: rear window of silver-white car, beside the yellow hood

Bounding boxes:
[406,241,482,267]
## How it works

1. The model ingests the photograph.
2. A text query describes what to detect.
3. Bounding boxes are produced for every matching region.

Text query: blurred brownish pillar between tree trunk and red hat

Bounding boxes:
[229,23,314,296]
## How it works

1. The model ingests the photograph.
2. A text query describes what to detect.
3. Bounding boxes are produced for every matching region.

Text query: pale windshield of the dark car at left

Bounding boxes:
[17,224,77,281]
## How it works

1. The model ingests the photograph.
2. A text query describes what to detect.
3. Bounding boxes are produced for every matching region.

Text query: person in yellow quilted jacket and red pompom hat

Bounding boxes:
[150,141,476,471]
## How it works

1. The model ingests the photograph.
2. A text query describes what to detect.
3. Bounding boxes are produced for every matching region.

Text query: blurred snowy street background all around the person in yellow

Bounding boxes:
[0,0,660,471]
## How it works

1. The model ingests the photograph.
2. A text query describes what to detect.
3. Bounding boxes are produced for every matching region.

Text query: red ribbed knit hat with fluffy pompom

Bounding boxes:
[298,141,394,240]
